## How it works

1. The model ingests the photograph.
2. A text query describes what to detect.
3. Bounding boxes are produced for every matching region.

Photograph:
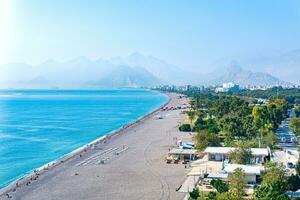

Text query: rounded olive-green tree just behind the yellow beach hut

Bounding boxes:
[193,130,220,151]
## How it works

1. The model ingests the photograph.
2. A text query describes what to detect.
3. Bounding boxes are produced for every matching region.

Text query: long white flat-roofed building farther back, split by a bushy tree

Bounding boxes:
[204,147,269,164]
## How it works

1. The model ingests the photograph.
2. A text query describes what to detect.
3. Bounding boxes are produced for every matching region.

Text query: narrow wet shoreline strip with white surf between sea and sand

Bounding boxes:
[0,91,171,197]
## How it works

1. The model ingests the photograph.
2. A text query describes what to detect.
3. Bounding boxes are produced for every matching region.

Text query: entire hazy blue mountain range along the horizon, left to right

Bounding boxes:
[0,53,296,89]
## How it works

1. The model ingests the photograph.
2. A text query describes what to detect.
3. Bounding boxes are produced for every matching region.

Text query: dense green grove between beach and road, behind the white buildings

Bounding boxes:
[175,91,290,149]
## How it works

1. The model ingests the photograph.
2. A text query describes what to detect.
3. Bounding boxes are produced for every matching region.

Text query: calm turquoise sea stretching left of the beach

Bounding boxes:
[0,90,167,187]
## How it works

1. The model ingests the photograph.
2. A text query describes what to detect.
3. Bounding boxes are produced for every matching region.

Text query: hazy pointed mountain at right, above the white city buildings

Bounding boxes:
[208,62,290,86]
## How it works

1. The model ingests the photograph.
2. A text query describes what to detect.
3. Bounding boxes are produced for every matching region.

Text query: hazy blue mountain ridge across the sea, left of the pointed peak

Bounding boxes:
[0,57,163,88]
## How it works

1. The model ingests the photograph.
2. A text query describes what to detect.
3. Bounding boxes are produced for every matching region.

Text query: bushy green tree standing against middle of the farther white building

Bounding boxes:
[229,145,253,165]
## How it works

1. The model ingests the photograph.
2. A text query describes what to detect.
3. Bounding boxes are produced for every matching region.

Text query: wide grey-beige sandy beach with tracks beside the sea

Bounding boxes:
[0,94,191,200]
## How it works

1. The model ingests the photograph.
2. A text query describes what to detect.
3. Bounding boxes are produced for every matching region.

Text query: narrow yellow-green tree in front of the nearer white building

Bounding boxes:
[228,168,246,199]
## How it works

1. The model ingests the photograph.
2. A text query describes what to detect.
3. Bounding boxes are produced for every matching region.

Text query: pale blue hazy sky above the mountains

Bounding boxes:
[0,0,300,69]
